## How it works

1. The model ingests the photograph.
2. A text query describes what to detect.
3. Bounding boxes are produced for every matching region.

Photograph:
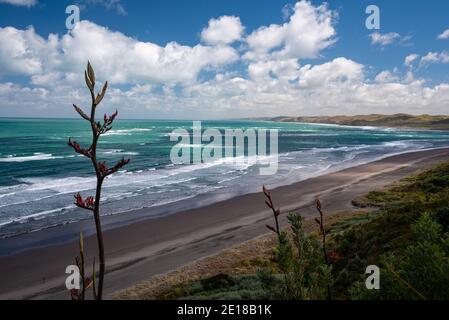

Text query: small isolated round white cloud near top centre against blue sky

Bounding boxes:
[201,16,245,45]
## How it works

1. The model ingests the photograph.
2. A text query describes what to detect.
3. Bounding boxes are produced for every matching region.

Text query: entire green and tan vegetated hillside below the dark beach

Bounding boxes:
[118,162,449,300]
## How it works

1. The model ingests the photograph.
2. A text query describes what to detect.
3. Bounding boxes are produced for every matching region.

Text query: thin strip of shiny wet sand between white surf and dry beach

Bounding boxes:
[0,147,449,258]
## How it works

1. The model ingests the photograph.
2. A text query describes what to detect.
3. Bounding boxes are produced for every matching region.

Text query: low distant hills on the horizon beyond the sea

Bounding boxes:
[269,113,449,130]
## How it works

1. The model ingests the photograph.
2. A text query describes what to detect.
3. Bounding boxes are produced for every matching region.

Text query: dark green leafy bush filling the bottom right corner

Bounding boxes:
[349,213,449,300]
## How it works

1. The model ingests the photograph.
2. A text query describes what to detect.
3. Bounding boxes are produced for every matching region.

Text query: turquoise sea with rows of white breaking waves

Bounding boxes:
[0,119,449,238]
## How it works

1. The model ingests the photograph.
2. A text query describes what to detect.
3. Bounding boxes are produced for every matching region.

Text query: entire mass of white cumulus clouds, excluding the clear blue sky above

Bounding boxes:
[0,1,449,119]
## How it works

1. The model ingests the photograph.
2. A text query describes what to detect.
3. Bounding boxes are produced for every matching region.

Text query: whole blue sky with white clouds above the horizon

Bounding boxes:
[0,0,449,120]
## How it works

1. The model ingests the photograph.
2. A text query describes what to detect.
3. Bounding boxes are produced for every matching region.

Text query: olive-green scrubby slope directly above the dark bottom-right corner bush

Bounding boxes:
[334,162,449,298]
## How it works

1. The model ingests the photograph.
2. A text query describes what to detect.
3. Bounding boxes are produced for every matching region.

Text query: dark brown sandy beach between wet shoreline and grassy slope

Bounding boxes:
[0,148,449,299]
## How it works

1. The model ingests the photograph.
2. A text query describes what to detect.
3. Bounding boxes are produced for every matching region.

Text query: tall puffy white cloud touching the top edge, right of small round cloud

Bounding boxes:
[245,1,336,60]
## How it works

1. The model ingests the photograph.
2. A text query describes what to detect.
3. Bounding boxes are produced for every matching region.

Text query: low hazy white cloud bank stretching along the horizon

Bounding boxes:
[0,57,449,119]
